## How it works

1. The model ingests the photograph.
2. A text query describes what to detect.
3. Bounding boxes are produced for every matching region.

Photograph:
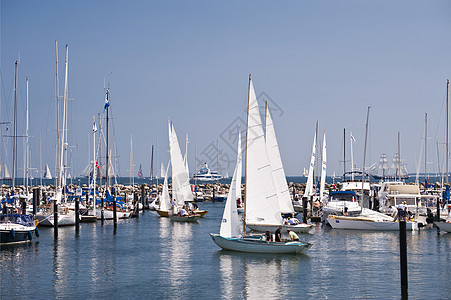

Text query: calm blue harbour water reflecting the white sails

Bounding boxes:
[0,203,451,299]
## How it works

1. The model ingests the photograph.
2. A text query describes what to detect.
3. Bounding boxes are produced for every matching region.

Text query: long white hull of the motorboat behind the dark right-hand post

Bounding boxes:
[328,216,418,231]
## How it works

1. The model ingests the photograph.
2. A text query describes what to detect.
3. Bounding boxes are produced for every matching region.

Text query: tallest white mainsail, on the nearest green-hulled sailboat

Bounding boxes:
[245,78,282,225]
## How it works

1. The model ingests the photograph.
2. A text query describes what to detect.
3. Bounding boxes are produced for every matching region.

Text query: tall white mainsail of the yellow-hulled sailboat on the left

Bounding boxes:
[169,120,194,206]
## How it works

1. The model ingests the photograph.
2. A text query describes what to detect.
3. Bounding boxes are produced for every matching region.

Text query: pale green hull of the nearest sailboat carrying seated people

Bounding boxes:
[210,233,312,254]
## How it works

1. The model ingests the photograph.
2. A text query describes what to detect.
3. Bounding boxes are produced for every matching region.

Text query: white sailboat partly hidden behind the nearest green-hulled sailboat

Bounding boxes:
[248,105,313,232]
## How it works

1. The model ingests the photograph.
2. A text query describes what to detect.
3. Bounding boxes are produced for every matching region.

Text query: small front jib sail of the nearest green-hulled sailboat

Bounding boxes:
[219,133,242,238]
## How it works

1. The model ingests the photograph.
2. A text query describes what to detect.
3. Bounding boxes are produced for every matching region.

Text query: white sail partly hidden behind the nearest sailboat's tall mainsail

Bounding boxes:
[266,106,294,213]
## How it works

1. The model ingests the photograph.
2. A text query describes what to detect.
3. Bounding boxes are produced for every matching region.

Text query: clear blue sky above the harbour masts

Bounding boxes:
[0,0,451,176]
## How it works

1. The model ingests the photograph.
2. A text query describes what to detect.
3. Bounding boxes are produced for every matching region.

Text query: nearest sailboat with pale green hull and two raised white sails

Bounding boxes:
[210,75,312,253]
